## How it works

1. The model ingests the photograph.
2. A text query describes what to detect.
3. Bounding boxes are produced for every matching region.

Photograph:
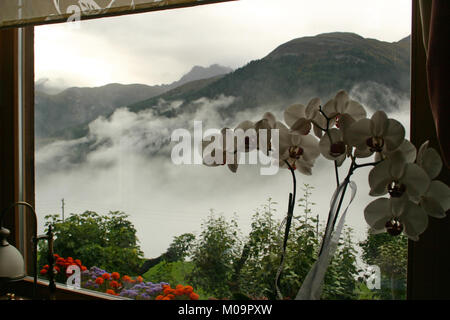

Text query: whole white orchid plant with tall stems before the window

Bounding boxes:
[203,91,450,299]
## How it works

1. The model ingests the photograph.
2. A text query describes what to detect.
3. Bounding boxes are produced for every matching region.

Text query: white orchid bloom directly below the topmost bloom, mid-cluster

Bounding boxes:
[319,128,348,166]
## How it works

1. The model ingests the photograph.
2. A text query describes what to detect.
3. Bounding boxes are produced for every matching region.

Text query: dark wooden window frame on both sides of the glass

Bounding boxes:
[0,0,450,300]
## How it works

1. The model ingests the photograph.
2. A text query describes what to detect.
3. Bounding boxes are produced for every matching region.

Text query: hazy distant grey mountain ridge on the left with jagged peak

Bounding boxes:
[35,64,232,142]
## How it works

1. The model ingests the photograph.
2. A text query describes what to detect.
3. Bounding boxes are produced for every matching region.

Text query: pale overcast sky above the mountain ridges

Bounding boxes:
[35,0,411,87]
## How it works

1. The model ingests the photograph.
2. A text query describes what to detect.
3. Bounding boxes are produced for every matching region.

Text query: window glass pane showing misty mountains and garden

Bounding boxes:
[35,0,411,299]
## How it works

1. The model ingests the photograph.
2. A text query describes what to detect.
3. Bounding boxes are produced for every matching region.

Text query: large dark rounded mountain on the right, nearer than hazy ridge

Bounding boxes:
[129,32,410,117]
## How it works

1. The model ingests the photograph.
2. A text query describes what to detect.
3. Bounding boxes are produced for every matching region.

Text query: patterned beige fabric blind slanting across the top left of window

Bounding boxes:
[0,0,234,28]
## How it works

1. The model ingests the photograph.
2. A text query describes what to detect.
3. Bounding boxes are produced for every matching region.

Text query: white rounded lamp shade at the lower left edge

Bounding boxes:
[0,228,25,282]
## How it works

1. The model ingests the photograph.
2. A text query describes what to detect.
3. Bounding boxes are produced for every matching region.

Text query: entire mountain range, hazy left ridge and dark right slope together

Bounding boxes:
[36,32,410,139]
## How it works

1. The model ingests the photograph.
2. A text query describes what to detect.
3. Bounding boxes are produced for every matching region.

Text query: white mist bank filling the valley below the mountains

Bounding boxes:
[36,88,409,257]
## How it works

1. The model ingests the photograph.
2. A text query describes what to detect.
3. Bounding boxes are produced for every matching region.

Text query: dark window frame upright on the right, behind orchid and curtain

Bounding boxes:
[407,0,450,300]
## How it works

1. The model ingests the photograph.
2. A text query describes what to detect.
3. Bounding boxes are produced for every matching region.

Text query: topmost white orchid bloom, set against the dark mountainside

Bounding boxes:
[322,90,367,128]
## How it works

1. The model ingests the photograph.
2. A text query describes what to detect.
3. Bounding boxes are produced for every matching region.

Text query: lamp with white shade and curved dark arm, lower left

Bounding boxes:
[0,201,56,299]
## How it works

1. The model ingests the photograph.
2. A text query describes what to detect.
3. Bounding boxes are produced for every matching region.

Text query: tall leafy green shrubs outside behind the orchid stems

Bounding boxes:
[188,185,357,299]
